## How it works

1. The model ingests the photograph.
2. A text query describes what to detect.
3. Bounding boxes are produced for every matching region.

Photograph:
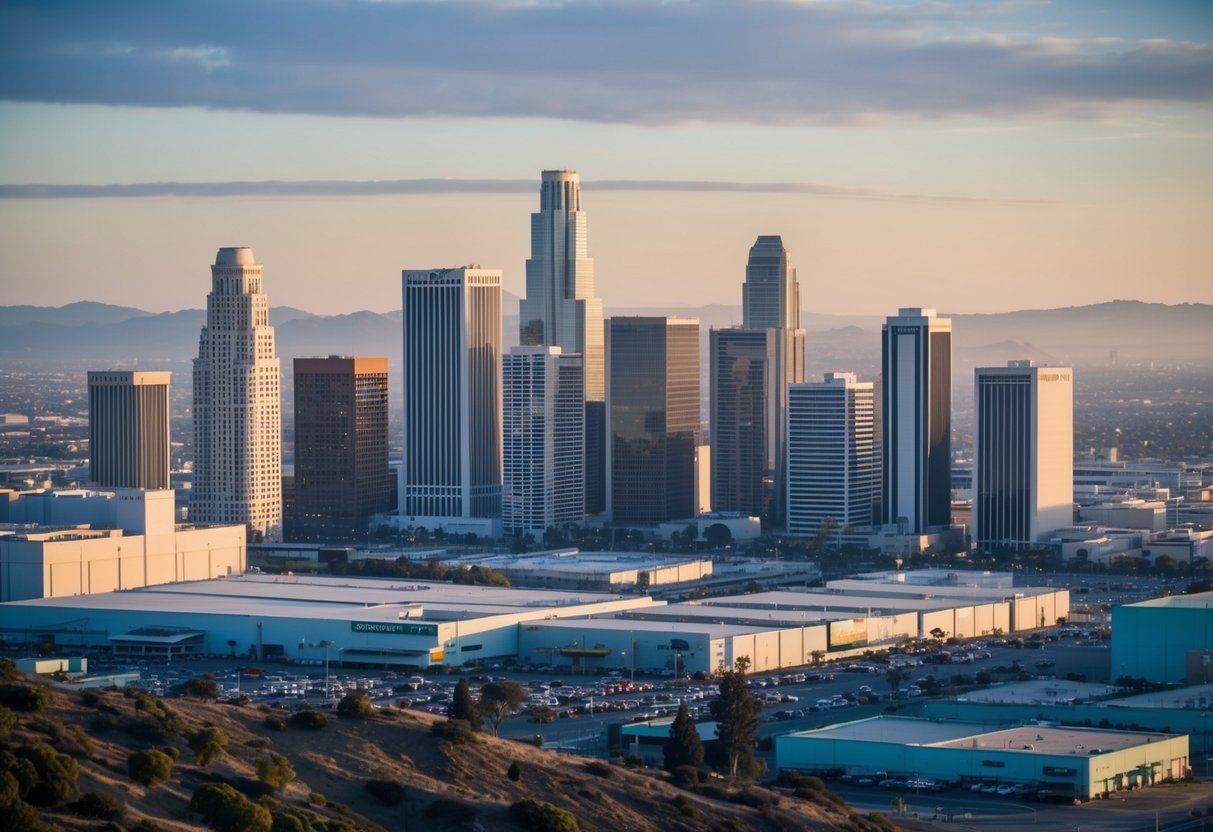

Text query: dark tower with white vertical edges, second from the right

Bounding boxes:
[881,308,952,535]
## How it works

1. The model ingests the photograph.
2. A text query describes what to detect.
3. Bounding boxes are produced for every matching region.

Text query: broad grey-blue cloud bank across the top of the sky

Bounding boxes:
[0,0,1213,124]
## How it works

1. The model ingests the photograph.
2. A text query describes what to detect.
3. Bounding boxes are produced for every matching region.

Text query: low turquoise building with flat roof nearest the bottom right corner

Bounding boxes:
[775,717,1189,800]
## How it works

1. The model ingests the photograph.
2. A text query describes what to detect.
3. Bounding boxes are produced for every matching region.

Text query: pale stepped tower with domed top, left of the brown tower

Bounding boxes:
[189,247,283,541]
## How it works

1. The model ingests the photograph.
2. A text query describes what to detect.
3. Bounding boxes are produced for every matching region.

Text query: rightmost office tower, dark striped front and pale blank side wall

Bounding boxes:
[973,361,1074,548]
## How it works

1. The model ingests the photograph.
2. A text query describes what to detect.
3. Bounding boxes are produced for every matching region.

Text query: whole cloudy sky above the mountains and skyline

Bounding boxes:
[0,0,1213,315]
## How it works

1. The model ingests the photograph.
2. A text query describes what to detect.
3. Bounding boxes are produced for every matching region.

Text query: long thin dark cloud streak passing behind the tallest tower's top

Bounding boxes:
[0,179,1049,205]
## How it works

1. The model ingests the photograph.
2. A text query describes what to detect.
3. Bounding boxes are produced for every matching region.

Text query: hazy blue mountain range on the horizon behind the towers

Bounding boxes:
[0,292,1213,377]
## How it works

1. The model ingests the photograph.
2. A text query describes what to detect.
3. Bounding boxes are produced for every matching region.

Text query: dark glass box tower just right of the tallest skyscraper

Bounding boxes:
[607,318,699,523]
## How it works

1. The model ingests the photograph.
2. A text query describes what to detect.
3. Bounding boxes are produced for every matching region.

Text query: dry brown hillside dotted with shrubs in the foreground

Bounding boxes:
[0,677,893,832]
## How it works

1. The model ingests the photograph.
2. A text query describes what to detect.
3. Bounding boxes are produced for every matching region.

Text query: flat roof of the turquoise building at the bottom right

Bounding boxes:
[791,717,1179,757]
